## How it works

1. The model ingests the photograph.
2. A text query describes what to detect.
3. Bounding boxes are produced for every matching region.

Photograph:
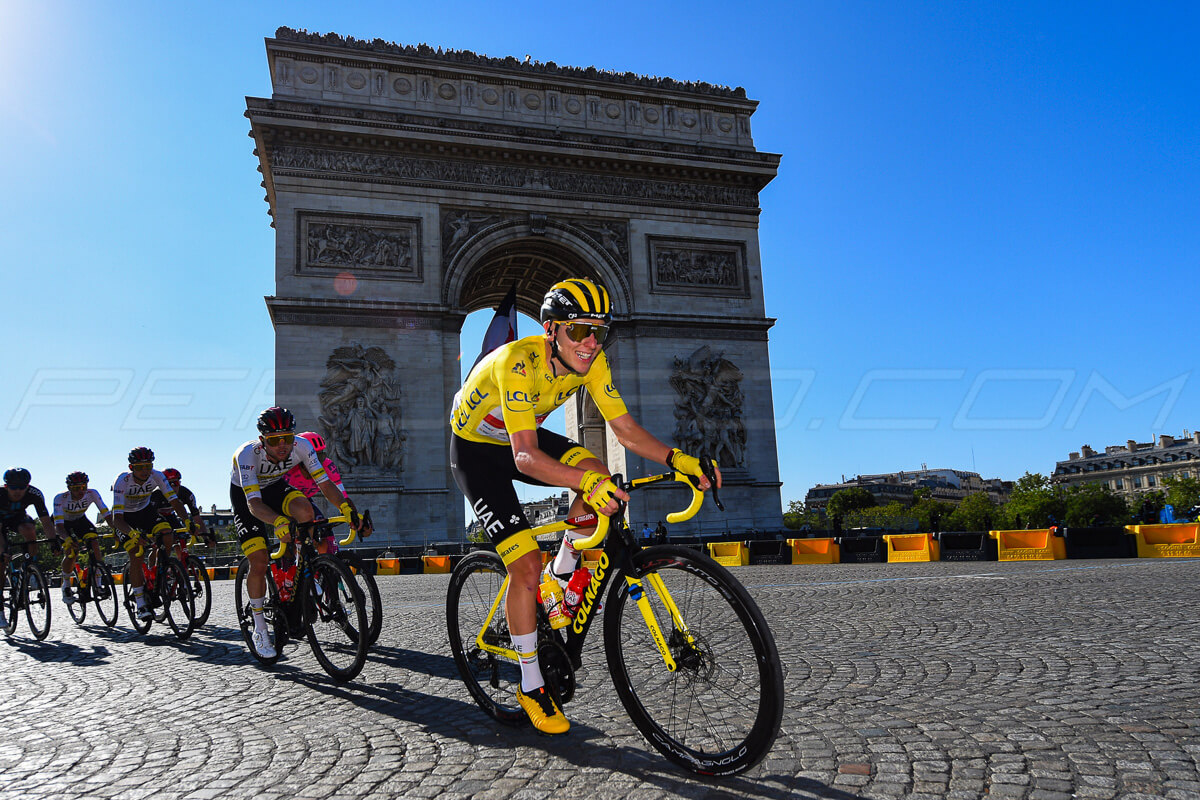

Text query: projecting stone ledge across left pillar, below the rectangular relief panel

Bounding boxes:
[264,296,466,332]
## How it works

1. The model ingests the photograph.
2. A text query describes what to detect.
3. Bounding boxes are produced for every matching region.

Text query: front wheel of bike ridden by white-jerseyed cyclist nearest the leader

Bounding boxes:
[300,555,368,682]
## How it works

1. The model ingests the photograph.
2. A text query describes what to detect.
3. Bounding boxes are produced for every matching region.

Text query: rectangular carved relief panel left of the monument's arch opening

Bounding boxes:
[296,210,421,281]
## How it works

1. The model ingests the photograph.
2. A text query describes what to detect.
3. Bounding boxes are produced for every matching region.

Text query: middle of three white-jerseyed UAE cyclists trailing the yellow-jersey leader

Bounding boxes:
[113,447,192,621]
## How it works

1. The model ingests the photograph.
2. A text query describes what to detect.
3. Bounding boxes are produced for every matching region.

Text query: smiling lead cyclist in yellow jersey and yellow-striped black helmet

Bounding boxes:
[450,278,721,734]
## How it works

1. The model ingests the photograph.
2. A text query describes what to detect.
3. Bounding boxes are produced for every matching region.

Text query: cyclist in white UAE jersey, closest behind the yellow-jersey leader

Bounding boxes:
[229,405,362,658]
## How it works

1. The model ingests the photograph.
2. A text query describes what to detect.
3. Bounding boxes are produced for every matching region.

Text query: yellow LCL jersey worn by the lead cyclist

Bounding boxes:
[450,336,628,444]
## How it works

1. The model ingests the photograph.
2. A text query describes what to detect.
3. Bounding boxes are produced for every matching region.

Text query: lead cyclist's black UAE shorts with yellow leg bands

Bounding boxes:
[450,428,594,545]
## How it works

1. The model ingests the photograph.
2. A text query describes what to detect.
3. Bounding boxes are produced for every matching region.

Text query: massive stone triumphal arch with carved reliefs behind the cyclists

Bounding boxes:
[246,28,781,545]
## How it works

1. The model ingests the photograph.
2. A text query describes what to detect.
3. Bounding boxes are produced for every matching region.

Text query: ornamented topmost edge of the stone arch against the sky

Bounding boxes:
[268,26,757,108]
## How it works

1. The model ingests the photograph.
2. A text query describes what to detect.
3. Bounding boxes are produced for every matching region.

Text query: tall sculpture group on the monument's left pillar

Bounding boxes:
[318,342,406,473]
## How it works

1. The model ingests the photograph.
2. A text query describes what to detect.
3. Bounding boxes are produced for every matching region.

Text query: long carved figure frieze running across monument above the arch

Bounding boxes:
[271,145,758,209]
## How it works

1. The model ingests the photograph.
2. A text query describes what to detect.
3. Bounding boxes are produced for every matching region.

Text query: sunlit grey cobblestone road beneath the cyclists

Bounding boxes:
[0,559,1200,800]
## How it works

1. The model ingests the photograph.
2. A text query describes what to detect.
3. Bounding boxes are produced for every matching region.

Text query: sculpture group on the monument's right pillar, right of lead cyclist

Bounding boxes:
[670,344,746,469]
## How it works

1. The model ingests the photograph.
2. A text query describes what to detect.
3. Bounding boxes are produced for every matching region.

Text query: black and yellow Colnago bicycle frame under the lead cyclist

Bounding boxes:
[475,473,720,672]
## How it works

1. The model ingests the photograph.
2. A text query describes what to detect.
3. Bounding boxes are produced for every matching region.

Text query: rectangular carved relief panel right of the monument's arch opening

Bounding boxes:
[647,236,750,297]
